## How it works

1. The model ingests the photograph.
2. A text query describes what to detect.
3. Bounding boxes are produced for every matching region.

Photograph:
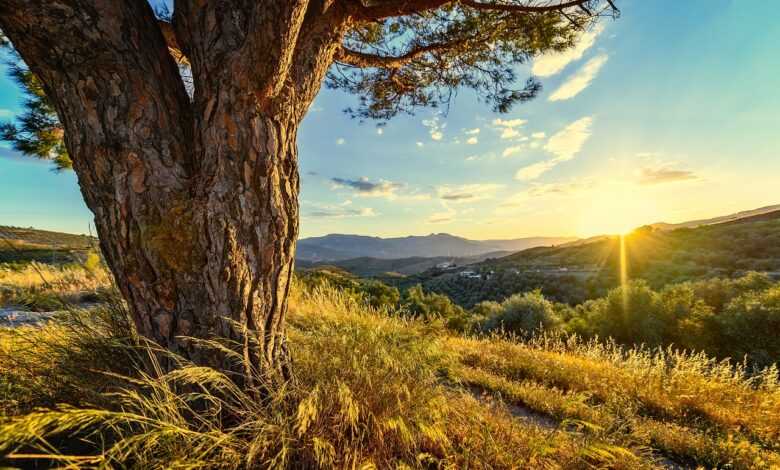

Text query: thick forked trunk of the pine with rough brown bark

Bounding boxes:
[0,0,343,375]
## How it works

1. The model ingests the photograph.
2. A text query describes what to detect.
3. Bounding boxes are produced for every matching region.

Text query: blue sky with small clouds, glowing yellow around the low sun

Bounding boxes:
[0,0,780,239]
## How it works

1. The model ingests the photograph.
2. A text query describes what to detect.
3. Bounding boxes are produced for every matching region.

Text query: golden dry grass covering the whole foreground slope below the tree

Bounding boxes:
[0,273,780,469]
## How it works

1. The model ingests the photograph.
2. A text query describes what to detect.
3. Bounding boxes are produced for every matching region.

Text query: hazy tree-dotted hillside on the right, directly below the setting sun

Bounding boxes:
[406,211,780,307]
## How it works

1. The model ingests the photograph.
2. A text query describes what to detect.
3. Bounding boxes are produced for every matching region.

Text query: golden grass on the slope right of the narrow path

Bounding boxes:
[446,337,780,468]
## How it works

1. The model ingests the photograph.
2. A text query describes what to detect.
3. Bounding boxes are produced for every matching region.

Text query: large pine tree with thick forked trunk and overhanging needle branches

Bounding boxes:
[0,0,617,375]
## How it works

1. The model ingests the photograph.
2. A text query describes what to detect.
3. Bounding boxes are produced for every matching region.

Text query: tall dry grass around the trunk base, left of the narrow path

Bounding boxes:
[0,280,656,469]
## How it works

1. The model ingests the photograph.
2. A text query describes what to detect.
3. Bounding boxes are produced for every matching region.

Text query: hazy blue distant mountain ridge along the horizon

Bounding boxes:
[296,233,576,262]
